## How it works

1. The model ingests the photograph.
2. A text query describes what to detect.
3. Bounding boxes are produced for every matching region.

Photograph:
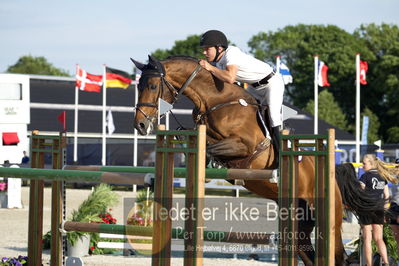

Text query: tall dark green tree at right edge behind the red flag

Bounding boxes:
[355,24,399,141]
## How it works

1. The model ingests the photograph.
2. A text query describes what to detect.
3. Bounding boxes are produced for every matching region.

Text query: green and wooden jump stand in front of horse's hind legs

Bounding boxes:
[279,129,335,266]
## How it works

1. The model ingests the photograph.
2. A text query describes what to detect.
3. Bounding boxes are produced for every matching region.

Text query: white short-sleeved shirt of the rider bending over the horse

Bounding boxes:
[216,46,273,84]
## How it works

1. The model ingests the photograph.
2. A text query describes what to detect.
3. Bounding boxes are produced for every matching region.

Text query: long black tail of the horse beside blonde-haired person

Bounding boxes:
[335,163,385,217]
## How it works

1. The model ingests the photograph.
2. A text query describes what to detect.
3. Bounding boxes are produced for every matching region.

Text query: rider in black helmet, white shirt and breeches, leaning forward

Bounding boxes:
[199,30,284,183]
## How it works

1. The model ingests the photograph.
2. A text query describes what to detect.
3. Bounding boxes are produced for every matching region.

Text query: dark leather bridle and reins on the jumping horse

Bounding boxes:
[135,64,202,123]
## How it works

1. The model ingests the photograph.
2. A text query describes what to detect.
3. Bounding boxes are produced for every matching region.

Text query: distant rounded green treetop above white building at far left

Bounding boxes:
[7,55,70,76]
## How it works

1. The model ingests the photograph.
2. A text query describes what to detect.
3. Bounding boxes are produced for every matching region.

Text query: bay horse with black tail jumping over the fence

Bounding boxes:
[131,56,386,265]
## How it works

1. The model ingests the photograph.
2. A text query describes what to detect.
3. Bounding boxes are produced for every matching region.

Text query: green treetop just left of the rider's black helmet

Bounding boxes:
[151,35,204,60]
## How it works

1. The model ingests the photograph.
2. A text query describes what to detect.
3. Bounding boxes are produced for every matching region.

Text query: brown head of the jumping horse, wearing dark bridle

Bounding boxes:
[130,55,170,135]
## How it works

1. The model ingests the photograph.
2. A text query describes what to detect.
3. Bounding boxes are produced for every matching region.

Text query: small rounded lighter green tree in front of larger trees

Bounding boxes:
[305,90,347,130]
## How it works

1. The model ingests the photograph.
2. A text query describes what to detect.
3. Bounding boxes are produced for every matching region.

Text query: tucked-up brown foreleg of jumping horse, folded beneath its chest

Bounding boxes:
[206,137,248,158]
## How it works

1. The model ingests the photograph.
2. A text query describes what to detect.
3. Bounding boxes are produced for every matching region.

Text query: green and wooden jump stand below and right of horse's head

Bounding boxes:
[152,125,206,266]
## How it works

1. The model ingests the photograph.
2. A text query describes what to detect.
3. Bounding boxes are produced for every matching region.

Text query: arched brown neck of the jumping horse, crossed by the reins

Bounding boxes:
[165,61,247,111]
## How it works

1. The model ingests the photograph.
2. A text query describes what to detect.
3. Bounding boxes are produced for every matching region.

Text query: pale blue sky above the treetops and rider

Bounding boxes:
[0,0,399,75]
